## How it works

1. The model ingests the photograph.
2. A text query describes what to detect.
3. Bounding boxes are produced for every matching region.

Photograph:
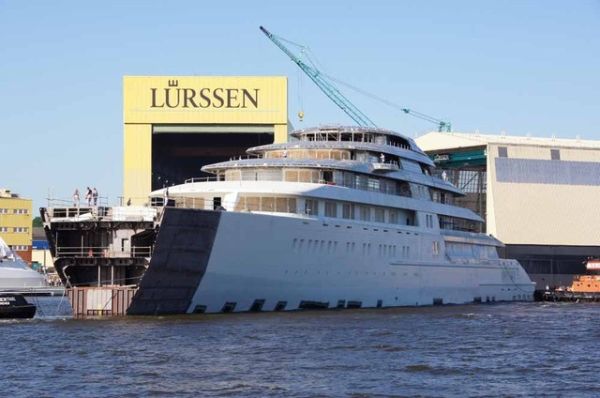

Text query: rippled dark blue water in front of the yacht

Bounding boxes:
[0,298,600,397]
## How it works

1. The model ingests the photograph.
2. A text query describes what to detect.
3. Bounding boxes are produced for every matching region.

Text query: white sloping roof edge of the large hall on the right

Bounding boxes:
[415,131,600,151]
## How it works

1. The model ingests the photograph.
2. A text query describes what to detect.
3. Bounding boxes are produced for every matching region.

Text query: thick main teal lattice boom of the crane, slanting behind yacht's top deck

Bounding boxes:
[260,26,377,127]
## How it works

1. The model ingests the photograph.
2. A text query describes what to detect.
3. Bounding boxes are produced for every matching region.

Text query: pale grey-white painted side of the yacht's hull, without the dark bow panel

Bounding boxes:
[187,212,534,313]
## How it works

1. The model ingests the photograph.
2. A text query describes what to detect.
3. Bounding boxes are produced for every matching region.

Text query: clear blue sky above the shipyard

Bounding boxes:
[0,0,600,211]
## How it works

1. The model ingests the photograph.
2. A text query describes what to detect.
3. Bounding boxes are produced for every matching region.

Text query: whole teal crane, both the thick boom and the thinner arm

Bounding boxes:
[260,26,452,131]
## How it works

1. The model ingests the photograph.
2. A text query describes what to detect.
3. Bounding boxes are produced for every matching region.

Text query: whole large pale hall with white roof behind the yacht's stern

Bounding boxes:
[416,132,600,289]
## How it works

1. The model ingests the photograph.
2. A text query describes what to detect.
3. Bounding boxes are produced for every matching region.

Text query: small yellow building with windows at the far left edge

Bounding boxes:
[0,188,32,262]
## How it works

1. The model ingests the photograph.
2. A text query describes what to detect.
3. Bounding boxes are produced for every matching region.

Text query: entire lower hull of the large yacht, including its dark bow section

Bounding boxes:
[128,208,534,315]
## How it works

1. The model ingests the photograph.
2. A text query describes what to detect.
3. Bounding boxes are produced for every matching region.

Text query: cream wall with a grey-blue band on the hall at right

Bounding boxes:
[488,144,600,246]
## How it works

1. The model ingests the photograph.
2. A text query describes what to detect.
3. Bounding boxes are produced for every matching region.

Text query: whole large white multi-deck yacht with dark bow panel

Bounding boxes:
[142,126,534,314]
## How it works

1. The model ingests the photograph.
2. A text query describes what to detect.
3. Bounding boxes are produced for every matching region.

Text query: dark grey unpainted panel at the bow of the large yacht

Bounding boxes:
[127,208,221,315]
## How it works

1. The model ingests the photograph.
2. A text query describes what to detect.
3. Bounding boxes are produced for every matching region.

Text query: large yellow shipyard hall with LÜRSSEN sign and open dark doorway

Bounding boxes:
[123,76,288,204]
